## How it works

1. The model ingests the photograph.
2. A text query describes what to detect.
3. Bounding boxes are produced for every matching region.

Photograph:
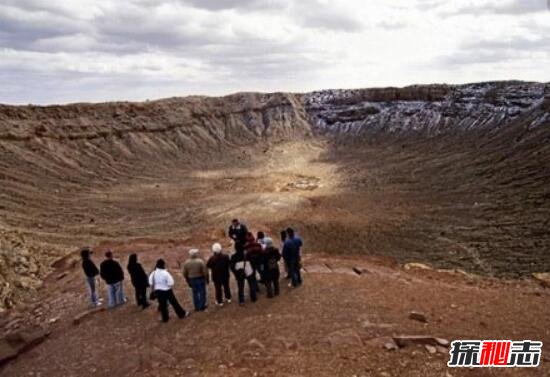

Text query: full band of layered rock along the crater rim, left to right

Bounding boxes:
[0,82,550,158]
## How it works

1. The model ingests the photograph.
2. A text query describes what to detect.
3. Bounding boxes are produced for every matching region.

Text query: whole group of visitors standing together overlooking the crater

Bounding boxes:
[81,219,303,322]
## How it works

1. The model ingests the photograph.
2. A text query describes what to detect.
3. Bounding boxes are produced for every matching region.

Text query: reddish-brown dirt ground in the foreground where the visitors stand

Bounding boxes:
[0,238,550,377]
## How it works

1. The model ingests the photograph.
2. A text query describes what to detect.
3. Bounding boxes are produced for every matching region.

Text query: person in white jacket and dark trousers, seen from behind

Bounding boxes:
[149,259,187,322]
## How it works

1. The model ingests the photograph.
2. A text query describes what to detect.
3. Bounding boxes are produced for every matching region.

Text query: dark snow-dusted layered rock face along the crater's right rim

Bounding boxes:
[305,82,550,136]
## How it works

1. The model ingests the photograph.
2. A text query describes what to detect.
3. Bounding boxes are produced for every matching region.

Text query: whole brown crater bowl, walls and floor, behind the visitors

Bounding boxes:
[0,82,550,307]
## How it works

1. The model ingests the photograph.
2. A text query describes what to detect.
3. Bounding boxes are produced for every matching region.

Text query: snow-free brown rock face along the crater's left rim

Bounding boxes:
[0,93,310,144]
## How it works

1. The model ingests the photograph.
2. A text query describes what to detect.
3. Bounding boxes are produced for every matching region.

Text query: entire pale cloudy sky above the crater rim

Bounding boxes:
[0,0,550,104]
